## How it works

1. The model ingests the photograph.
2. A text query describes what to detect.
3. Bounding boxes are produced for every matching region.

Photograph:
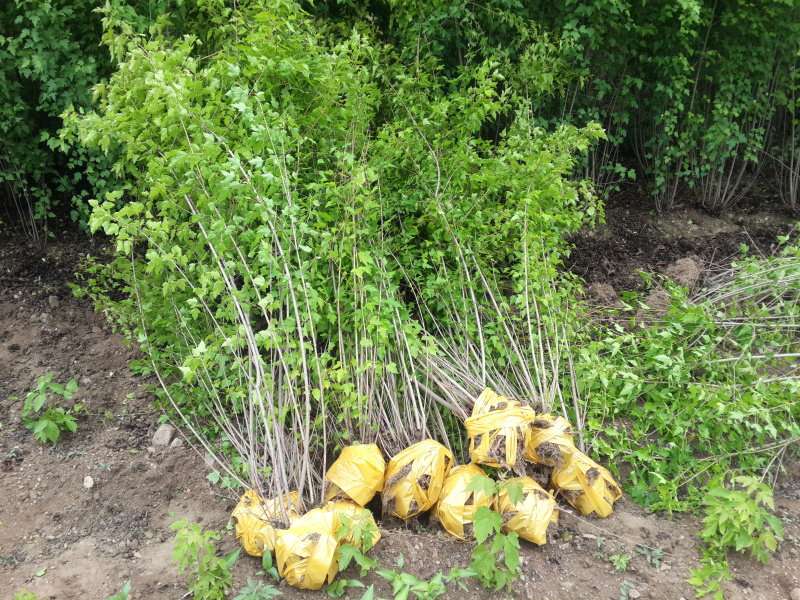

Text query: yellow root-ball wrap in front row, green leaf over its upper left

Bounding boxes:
[494,477,558,545]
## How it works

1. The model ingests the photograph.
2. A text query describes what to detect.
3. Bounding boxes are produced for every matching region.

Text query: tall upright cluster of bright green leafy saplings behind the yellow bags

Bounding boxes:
[69,2,602,502]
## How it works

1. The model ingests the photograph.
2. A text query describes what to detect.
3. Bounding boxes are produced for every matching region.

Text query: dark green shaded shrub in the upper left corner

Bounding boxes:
[0,0,116,239]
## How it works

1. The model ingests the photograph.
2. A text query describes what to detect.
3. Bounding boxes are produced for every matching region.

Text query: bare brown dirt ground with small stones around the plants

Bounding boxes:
[0,198,800,600]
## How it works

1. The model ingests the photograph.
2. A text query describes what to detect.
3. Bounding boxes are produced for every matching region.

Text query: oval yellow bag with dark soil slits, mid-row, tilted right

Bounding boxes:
[383,440,453,520]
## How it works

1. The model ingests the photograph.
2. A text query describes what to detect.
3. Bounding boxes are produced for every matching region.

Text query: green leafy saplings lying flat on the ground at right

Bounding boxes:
[576,240,800,511]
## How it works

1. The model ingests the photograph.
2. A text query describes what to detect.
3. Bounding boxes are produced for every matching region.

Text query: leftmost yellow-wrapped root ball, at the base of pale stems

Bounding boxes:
[231,490,302,556]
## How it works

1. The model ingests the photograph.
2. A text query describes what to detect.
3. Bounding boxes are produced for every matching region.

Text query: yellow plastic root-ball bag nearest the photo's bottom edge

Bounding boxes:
[275,508,341,590]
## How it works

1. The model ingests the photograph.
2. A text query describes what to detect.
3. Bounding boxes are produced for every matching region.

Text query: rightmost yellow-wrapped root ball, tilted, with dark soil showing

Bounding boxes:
[552,450,622,518]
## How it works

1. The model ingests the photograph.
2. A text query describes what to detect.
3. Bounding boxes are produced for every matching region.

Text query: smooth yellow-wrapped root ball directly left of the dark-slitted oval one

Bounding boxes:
[325,444,386,506]
